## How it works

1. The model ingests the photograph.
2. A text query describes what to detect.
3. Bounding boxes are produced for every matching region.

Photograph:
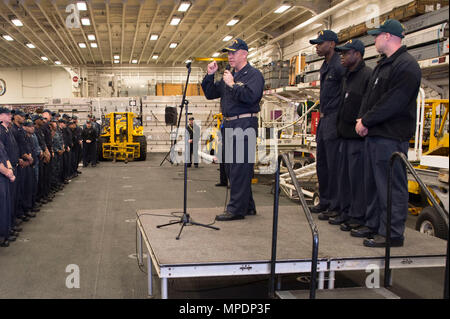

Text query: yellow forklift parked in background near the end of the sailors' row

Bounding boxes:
[98,112,147,163]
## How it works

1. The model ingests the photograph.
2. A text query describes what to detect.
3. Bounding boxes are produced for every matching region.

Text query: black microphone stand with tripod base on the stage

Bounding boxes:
[156,62,219,240]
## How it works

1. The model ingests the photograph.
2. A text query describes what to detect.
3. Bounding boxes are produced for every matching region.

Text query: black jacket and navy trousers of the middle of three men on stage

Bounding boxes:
[337,61,372,225]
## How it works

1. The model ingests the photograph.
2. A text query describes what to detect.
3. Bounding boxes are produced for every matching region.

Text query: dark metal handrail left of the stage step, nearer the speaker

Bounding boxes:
[269,154,319,299]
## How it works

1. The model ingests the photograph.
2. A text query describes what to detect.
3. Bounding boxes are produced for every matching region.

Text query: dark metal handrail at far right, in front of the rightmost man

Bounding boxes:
[384,152,449,299]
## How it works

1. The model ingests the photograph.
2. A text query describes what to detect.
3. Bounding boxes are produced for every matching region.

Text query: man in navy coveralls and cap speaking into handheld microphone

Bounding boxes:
[202,39,264,221]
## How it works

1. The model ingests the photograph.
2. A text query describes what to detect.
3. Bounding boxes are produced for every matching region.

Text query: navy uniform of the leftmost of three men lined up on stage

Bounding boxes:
[316,53,345,213]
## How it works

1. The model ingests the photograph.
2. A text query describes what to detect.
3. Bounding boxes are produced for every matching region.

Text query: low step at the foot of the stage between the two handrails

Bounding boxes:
[275,287,400,299]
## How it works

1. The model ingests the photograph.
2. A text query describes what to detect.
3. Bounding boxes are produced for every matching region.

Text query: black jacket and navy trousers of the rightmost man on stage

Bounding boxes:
[358,46,422,240]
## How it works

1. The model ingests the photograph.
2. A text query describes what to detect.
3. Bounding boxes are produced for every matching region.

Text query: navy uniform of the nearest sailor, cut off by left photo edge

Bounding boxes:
[0,141,11,242]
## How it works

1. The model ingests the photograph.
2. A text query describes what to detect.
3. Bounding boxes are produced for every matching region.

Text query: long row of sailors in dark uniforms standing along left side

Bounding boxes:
[0,107,100,247]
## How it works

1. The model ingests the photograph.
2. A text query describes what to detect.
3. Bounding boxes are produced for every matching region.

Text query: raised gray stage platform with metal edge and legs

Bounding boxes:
[136,206,447,299]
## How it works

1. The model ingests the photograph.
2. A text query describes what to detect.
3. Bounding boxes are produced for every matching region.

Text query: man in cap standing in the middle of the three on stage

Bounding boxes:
[328,40,372,231]
